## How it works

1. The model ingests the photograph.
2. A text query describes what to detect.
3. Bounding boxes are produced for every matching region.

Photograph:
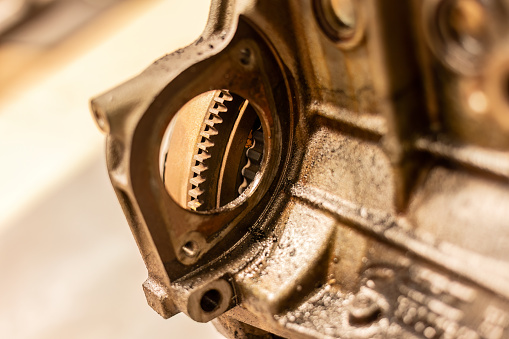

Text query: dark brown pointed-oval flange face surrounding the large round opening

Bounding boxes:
[118,24,293,270]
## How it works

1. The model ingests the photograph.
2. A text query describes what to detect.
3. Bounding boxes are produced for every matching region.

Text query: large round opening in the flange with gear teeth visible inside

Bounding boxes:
[160,90,266,211]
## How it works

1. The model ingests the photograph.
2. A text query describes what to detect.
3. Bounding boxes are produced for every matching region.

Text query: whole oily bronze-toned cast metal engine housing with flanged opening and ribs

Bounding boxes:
[91,0,509,339]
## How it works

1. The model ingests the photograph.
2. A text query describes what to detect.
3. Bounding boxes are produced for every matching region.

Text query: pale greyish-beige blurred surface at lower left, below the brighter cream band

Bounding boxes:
[0,154,222,339]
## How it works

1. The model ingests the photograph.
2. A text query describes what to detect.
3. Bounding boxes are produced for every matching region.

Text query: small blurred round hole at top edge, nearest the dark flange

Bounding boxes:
[314,0,357,41]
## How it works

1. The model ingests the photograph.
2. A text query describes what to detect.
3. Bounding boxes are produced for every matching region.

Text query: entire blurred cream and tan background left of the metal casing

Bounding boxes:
[0,0,221,338]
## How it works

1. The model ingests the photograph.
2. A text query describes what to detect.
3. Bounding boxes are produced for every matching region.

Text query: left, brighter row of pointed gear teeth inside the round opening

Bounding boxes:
[187,90,233,210]
